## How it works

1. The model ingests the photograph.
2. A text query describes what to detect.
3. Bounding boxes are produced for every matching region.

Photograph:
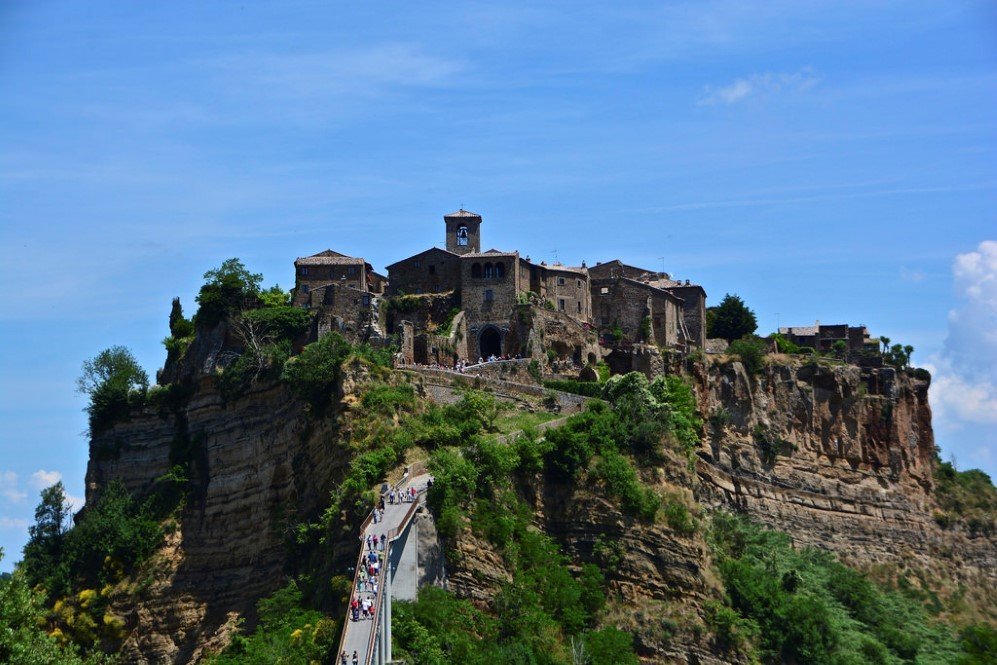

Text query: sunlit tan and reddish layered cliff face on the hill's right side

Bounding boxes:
[694,358,997,618]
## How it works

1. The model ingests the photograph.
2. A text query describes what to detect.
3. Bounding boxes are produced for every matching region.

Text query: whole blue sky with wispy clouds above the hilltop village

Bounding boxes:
[0,1,997,569]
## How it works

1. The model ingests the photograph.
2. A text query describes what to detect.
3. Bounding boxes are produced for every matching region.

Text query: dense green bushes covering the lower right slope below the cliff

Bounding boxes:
[709,513,997,665]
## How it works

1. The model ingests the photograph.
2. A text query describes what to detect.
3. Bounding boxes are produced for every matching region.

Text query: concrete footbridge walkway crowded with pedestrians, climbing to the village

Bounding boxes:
[335,473,430,665]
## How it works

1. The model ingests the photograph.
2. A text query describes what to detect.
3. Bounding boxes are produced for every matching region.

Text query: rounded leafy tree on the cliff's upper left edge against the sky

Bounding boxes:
[76,346,149,435]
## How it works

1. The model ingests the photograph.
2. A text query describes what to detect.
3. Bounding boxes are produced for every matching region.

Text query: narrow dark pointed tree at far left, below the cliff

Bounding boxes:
[21,481,71,590]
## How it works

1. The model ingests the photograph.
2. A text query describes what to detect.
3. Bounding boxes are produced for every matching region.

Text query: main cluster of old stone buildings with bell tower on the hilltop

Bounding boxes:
[294,209,706,370]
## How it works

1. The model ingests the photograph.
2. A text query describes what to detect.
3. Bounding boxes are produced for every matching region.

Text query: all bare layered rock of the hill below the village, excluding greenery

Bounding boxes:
[81,350,997,663]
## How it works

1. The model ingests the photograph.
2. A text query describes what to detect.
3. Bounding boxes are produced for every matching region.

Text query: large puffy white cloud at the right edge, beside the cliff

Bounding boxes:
[930,240,997,428]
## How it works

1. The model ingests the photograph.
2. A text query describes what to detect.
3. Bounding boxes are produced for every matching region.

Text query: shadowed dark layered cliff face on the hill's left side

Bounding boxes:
[87,374,351,663]
